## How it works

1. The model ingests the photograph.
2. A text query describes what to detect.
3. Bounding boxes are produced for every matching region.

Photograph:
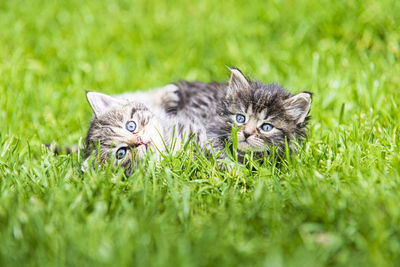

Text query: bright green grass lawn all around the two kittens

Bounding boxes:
[0,0,400,266]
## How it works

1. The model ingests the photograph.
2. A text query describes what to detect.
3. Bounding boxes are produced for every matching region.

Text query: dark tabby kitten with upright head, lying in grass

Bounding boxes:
[168,69,311,159]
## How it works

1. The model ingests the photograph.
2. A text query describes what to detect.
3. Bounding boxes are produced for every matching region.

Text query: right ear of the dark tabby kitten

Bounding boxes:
[284,92,312,124]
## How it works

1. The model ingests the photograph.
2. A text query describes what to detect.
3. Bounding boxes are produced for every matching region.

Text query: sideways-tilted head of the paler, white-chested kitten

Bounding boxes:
[85,92,160,176]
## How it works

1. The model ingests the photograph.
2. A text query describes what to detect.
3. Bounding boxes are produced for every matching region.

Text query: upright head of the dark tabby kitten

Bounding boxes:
[223,69,311,156]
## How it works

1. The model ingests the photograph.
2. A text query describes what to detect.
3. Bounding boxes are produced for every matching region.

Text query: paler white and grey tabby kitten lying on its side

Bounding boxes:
[83,92,207,176]
